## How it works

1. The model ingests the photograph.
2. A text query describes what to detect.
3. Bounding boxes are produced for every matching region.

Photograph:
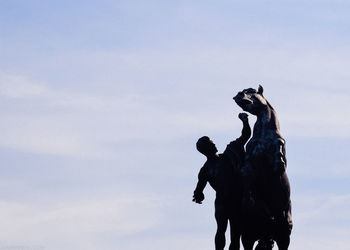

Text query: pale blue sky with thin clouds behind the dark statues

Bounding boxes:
[0,0,350,250]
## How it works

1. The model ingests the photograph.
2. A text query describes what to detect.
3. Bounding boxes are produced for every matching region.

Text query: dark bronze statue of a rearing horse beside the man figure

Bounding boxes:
[233,86,292,250]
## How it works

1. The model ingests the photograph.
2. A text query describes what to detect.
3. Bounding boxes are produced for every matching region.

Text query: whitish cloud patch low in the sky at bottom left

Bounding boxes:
[0,194,159,249]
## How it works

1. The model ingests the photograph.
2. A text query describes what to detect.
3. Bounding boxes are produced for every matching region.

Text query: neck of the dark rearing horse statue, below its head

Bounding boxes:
[253,104,279,137]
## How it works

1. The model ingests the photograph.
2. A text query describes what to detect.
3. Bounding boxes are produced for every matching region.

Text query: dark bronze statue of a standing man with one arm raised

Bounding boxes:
[193,113,251,250]
